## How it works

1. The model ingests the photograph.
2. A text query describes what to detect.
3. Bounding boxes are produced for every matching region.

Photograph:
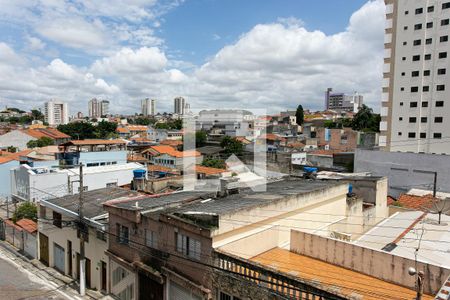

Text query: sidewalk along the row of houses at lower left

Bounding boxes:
[0,241,113,300]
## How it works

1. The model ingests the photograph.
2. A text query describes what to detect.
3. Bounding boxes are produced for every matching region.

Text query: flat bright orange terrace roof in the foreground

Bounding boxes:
[251,248,434,300]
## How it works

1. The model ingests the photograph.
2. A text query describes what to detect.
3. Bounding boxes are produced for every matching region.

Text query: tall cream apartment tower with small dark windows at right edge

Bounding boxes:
[379,0,450,154]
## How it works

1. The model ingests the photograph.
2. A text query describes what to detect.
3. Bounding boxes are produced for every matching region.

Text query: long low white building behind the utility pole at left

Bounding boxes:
[10,163,143,202]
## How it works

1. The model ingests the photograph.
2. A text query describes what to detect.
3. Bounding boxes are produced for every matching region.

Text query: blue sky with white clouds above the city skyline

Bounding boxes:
[0,0,385,114]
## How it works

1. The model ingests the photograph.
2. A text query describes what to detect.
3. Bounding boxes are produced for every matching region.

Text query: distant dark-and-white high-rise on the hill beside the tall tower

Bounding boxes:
[325,88,363,113]
